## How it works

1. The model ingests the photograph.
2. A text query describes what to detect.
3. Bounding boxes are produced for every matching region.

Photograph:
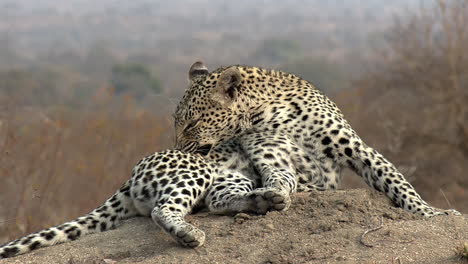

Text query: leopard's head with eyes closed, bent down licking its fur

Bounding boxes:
[174,62,252,154]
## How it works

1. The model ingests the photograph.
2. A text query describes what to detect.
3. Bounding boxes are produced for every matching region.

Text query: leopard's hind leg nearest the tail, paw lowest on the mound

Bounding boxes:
[147,153,218,248]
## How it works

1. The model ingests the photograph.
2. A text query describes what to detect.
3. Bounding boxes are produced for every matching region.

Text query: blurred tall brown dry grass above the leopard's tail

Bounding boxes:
[0,96,172,242]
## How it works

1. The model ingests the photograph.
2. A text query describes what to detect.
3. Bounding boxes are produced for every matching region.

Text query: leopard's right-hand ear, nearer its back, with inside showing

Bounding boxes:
[211,66,242,106]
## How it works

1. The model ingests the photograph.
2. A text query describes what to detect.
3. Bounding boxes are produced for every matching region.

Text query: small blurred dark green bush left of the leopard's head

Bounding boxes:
[110,64,162,98]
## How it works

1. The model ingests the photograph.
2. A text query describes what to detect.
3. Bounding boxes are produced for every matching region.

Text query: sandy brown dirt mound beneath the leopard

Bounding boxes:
[0,189,468,264]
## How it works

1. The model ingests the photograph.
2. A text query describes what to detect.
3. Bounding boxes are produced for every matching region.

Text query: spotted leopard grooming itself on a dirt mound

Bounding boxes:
[0,62,459,258]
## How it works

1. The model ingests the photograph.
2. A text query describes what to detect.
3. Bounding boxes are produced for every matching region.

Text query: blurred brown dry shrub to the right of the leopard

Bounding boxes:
[336,0,468,212]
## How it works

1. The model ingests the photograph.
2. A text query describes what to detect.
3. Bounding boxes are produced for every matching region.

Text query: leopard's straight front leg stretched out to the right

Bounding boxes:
[318,121,459,217]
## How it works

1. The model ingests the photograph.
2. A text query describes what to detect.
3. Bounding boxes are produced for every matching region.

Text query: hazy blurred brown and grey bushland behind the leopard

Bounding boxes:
[0,0,468,243]
